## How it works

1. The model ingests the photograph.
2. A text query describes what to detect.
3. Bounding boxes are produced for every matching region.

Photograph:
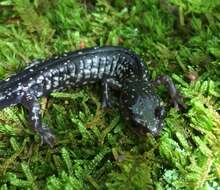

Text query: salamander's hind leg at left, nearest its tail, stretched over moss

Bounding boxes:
[21,95,54,147]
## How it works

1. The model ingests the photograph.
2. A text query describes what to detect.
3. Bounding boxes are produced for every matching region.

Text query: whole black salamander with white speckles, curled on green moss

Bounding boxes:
[0,46,181,147]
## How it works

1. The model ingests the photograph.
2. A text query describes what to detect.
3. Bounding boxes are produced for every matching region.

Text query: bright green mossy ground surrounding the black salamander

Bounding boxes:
[0,0,220,190]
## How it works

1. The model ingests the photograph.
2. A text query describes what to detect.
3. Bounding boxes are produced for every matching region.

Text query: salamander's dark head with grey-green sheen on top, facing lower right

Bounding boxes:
[121,83,165,136]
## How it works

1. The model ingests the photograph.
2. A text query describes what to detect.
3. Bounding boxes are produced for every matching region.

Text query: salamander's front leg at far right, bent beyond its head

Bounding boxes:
[152,75,186,109]
